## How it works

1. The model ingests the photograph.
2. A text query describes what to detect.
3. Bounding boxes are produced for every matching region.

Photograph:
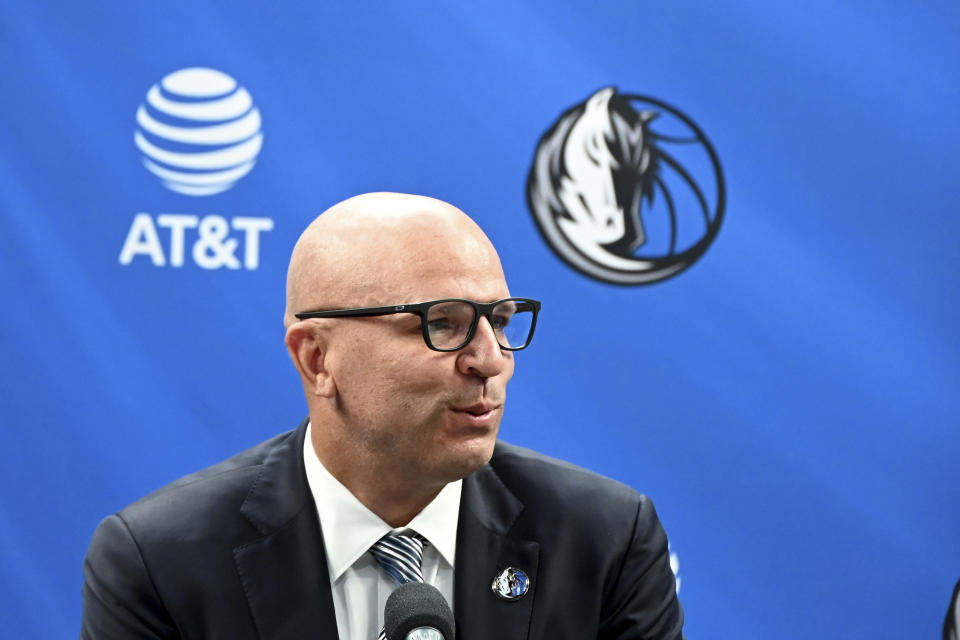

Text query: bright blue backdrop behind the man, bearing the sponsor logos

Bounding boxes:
[0,0,960,640]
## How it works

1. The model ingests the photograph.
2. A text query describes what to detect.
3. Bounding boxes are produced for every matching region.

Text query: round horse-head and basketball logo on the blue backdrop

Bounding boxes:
[527,87,725,285]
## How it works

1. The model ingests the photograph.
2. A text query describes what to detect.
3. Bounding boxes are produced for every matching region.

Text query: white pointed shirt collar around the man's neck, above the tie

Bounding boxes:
[303,424,463,583]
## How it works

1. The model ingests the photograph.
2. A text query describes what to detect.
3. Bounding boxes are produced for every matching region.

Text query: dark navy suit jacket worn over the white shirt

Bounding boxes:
[80,423,683,640]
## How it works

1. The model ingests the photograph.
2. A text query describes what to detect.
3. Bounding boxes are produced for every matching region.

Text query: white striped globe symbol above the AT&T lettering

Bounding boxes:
[133,67,263,196]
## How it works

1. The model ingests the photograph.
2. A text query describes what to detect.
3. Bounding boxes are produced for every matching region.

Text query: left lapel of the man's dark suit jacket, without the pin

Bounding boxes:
[233,422,337,640]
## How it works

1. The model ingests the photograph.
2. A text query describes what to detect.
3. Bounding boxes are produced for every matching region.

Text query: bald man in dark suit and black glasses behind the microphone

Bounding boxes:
[81,193,683,640]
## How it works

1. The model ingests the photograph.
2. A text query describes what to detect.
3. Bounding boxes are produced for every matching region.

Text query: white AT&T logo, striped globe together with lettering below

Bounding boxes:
[119,67,273,270]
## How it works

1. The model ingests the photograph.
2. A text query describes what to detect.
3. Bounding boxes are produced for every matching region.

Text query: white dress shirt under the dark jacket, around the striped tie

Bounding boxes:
[303,425,463,640]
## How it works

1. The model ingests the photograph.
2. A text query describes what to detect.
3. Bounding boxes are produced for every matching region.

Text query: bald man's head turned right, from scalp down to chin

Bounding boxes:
[284,193,514,498]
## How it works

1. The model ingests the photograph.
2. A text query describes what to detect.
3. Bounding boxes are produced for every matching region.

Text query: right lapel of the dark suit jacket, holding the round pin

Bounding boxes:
[454,465,540,640]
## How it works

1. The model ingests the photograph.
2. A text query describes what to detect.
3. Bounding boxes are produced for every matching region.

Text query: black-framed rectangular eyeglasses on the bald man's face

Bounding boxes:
[296,298,540,351]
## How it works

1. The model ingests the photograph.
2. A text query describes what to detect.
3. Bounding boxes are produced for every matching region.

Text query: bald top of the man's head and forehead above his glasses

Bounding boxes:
[287,194,509,318]
